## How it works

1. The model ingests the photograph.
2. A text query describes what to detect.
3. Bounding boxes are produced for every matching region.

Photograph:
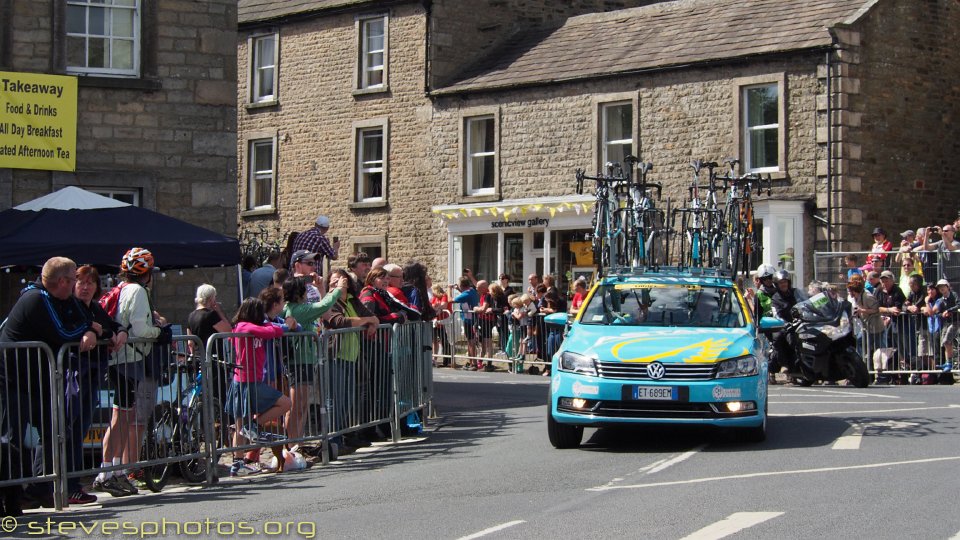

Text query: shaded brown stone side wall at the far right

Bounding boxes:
[836,0,960,249]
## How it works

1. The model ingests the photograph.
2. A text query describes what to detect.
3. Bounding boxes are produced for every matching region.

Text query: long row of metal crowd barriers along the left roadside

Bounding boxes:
[0,322,433,509]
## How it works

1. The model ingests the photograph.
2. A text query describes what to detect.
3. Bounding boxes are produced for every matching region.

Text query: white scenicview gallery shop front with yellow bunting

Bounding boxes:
[433,196,594,291]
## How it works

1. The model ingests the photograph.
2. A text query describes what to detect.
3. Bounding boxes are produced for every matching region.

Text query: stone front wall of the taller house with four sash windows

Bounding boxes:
[237,4,445,274]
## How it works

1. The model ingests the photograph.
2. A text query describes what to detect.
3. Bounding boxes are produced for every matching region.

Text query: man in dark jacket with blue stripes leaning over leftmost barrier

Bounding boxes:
[0,257,99,516]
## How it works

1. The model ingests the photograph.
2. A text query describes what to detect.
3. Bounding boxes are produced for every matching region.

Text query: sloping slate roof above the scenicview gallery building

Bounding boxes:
[431,0,877,95]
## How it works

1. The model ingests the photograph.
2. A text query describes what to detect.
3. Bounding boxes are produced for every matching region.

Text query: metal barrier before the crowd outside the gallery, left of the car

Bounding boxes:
[444,309,564,373]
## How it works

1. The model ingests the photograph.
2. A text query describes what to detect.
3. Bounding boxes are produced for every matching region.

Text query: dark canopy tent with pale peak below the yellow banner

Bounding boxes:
[0,187,241,268]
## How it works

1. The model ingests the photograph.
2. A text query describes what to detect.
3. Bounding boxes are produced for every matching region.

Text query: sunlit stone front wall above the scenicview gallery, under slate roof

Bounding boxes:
[424,55,822,280]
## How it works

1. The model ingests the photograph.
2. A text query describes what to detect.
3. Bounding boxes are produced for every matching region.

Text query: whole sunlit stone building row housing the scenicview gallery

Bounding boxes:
[238,0,960,292]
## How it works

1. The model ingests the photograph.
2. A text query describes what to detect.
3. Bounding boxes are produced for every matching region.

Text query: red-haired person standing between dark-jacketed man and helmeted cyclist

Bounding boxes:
[69,266,127,504]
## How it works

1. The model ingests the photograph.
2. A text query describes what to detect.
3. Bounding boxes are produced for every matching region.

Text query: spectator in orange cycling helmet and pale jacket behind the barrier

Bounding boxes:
[93,247,166,497]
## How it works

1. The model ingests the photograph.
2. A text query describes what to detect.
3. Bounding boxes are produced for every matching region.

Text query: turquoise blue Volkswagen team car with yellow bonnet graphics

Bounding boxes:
[547,271,778,448]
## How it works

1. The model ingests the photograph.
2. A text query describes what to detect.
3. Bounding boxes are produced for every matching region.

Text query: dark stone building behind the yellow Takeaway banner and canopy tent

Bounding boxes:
[0,0,237,321]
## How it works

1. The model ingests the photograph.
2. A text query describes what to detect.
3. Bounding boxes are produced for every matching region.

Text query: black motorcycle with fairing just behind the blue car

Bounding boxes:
[777,293,870,388]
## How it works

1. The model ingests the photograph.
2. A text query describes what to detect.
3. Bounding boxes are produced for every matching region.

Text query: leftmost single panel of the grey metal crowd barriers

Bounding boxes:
[0,341,64,510]
